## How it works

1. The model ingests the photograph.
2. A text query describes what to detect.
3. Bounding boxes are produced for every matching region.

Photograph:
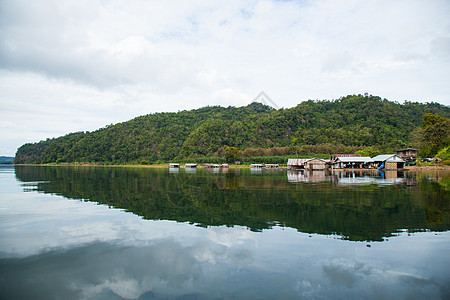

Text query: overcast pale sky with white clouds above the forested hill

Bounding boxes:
[0,0,450,156]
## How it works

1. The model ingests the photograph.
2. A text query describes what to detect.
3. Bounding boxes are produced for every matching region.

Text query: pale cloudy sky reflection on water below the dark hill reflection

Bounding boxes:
[0,168,450,299]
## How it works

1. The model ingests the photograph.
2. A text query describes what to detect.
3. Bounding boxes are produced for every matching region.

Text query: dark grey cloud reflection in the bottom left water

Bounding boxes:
[0,240,201,299]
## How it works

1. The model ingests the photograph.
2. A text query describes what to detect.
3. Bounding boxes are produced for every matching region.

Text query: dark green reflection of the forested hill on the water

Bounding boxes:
[15,167,450,241]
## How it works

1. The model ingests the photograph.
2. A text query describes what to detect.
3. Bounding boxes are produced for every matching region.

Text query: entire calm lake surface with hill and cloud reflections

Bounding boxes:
[0,166,450,299]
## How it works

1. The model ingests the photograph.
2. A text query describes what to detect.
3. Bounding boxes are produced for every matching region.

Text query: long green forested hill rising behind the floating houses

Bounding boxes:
[14,95,450,164]
